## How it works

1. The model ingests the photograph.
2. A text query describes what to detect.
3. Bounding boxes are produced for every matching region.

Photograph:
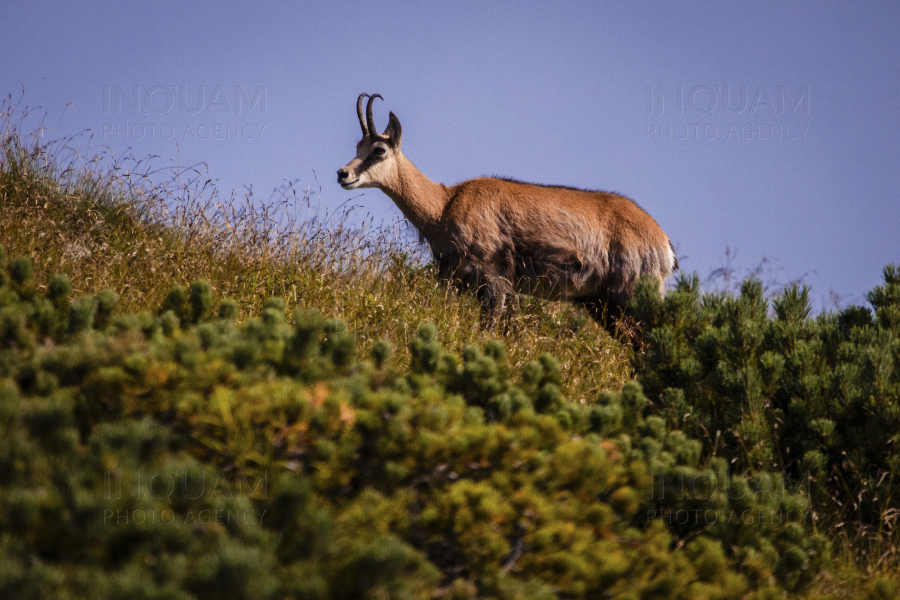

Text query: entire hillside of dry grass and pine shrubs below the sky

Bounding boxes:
[0,105,900,599]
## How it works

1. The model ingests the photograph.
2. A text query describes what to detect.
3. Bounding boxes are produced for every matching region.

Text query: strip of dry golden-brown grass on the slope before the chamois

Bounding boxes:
[0,96,632,403]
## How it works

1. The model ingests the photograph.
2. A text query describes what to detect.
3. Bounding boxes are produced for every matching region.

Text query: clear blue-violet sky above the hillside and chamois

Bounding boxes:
[0,1,900,306]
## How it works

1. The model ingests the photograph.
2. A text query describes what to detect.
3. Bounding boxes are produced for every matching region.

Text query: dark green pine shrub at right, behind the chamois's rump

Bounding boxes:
[633,265,900,554]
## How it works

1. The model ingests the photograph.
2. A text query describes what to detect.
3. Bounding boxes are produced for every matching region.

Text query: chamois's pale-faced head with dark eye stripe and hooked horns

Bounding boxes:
[338,94,401,190]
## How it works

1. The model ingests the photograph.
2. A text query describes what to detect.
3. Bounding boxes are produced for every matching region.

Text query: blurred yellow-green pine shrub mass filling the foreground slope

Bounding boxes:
[0,251,829,598]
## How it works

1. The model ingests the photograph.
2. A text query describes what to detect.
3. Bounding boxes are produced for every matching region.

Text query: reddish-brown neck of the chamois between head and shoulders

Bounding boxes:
[378,153,449,234]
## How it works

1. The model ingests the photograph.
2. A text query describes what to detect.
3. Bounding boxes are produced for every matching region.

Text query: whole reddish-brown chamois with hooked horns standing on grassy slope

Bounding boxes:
[337,94,678,332]
